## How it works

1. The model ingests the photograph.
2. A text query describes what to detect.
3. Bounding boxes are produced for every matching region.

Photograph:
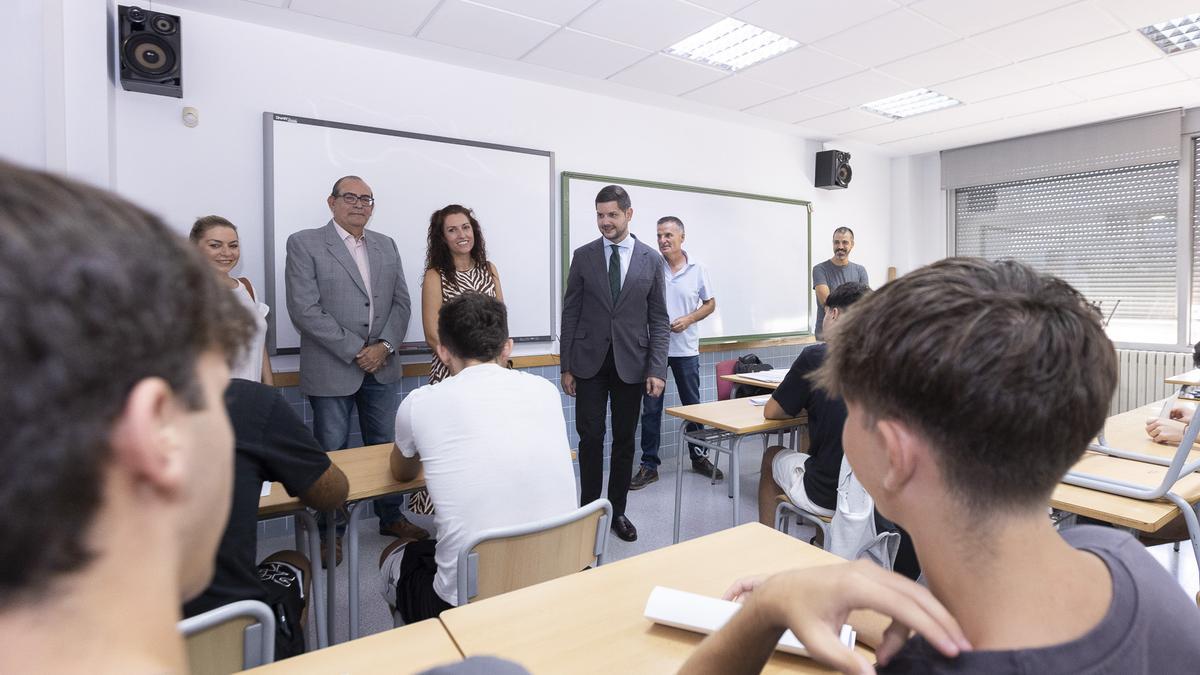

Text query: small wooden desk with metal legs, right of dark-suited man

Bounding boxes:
[666,399,808,543]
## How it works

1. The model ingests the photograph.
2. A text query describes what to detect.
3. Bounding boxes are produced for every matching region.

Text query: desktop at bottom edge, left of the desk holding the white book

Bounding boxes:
[244,619,462,675]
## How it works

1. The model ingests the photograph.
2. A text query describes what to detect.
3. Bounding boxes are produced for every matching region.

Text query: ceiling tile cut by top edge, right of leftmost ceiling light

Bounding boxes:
[733,0,898,43]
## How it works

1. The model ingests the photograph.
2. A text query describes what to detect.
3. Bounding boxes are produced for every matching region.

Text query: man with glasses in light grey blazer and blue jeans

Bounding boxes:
[284,175,428,539]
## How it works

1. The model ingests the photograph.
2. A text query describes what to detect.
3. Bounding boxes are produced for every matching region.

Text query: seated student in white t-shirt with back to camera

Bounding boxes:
[380,293,576,623]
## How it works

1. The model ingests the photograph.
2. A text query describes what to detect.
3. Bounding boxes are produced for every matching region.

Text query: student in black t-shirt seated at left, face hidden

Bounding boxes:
[184,380,348,659]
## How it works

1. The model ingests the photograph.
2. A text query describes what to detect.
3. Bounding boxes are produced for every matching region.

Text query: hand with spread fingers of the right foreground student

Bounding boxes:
[743,560,971,673]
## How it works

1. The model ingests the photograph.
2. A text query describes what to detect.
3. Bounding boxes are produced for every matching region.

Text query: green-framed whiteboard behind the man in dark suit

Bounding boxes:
[562,172,815,342]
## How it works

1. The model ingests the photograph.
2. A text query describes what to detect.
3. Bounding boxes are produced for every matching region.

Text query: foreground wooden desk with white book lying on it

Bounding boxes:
[442,522,888,675]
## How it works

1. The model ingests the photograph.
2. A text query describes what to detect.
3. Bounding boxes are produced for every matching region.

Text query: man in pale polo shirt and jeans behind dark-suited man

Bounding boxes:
[629,216,724,490]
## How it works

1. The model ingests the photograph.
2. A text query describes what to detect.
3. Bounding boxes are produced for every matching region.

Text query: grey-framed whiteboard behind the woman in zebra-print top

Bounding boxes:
[263,113,556,353]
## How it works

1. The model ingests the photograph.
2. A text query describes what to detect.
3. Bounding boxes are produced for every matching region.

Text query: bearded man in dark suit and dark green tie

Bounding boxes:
[560,185,671,542]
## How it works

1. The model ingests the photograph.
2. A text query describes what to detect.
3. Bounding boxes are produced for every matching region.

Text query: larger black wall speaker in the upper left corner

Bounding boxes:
[116,5,184,98]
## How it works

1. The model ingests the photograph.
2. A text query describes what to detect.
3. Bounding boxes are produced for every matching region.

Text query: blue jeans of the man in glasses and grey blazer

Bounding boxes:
[308,372,404,526]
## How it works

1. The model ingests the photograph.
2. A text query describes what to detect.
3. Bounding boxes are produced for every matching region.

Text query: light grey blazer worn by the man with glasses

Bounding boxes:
[284,220,409,396]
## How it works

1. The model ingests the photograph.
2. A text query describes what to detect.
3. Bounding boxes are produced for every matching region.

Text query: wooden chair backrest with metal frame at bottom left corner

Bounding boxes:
[178,601,275,675]
